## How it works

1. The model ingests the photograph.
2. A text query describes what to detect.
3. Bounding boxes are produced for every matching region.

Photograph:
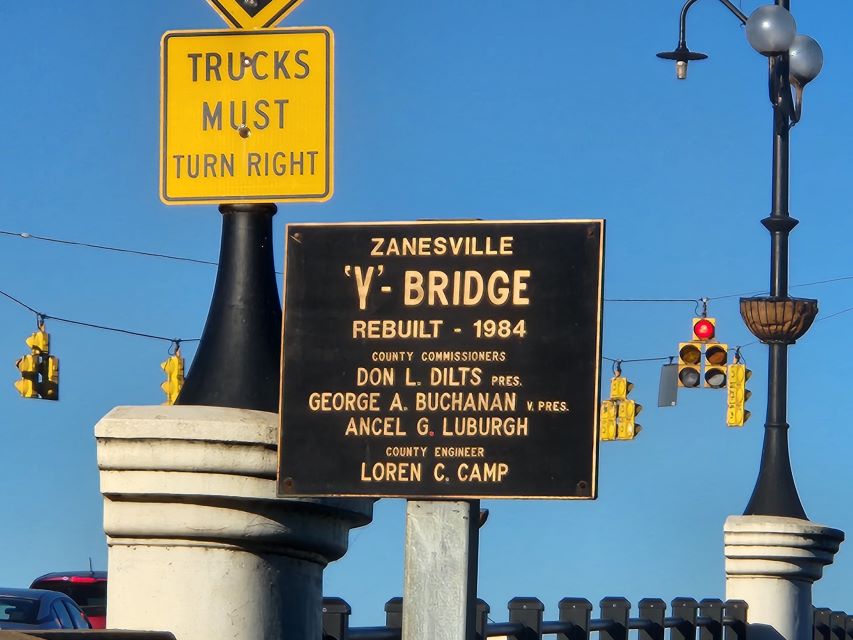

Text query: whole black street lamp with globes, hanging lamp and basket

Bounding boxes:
[658,0,823,520]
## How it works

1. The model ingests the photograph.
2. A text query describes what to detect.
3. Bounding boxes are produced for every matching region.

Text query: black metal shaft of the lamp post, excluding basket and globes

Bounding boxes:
[744,0,807,520]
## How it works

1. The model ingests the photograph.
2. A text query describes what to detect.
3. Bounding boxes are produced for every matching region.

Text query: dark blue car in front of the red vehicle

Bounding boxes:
[0,588,91,630]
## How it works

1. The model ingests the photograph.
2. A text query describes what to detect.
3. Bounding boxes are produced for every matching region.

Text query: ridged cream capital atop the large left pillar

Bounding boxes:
[95,406,372,564]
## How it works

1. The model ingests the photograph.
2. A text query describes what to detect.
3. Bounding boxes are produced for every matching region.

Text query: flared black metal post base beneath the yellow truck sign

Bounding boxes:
[175,204,281,412]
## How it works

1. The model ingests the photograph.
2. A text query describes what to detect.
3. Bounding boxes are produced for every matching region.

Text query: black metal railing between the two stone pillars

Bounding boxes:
[323,598,748,640]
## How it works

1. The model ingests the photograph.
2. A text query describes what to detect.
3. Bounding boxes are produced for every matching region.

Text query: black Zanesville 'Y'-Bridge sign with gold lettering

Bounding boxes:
[279,220,603,498]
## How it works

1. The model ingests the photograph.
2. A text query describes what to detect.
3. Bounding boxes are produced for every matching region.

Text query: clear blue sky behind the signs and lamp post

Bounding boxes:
[0,0,853,624]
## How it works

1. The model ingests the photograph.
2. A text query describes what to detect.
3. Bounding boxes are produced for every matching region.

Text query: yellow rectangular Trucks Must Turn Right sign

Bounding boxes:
[160,28,334,204]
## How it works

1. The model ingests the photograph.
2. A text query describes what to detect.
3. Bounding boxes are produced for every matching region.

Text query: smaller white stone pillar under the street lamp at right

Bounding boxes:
[724,516,844,640]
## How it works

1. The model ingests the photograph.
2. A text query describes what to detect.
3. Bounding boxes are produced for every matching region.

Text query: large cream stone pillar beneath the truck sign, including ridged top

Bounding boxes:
[95,406,373,640]
